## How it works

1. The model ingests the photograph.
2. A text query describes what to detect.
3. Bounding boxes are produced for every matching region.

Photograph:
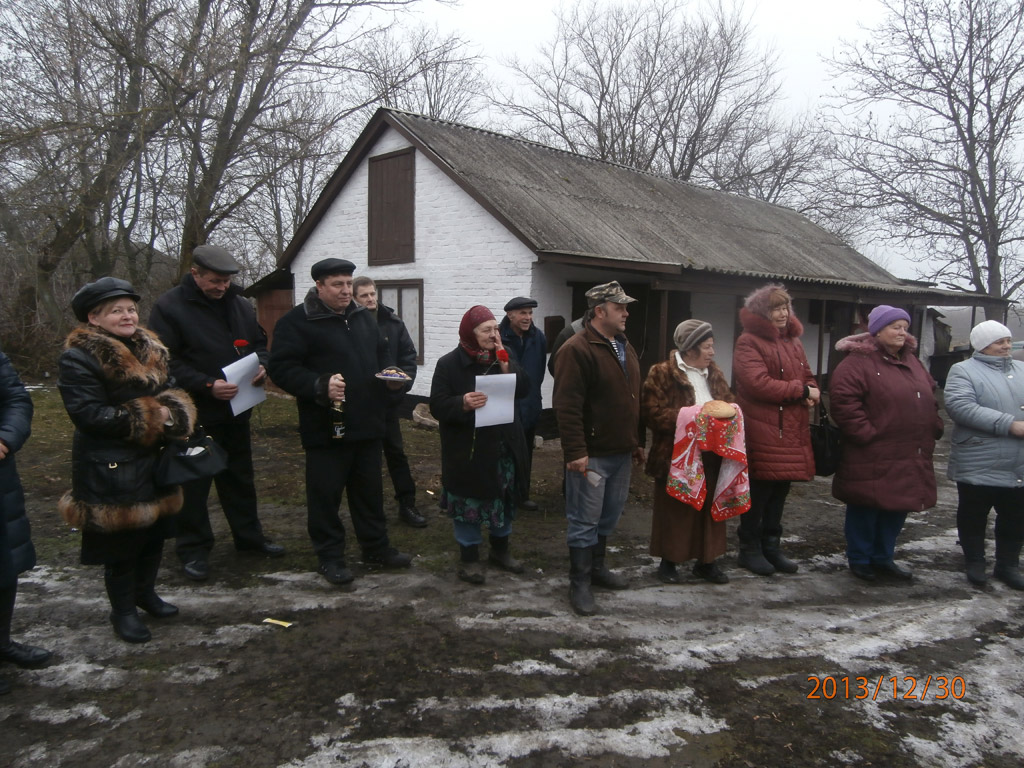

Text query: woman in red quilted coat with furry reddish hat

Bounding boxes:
[732,284,820,575]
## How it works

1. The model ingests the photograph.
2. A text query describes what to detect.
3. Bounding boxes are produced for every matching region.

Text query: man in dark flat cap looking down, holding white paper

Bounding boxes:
[150,245,285,582]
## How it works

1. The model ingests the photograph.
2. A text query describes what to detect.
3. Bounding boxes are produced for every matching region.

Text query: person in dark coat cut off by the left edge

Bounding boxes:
[0,352,50,694]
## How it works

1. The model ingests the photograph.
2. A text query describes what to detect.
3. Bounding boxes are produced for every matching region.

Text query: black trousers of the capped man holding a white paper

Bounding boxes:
[175,419,265,562]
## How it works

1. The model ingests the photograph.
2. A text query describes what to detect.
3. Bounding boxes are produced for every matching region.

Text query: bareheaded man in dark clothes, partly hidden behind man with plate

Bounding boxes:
[352,275,427,528]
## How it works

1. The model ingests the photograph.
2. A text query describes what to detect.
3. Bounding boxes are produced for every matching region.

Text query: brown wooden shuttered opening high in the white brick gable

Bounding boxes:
[367,147,416,266]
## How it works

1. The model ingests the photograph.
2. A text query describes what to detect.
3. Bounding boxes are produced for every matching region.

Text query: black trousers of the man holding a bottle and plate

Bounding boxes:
[306,440,389,562]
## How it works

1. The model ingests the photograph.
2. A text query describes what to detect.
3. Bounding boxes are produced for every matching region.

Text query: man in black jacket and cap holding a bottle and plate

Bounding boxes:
[269,258,412,584]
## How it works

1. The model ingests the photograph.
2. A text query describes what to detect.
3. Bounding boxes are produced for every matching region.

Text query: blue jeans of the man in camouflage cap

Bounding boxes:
[565,454,633,547]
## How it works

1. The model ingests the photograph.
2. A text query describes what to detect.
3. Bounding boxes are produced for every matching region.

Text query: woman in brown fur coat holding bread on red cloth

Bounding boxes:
[640,319,735,584]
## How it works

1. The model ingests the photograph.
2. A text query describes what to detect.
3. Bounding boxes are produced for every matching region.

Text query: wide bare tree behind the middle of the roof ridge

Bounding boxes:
[501,0,819,203]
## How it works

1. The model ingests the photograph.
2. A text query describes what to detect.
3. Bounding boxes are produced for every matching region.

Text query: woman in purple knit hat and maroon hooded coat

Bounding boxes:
[828,304,943,582]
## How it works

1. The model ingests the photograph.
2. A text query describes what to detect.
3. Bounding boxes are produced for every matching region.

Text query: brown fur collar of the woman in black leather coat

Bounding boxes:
[65,326,170,389]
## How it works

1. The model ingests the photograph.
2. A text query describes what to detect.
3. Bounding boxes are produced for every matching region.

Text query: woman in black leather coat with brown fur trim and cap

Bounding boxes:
[59,278,196,643]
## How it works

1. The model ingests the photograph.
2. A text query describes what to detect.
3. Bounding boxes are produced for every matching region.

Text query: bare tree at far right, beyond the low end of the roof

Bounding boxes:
[828,0,1024,316]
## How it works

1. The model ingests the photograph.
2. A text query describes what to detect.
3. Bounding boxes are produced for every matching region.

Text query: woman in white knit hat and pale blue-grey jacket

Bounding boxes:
[946,321,1024,590]
